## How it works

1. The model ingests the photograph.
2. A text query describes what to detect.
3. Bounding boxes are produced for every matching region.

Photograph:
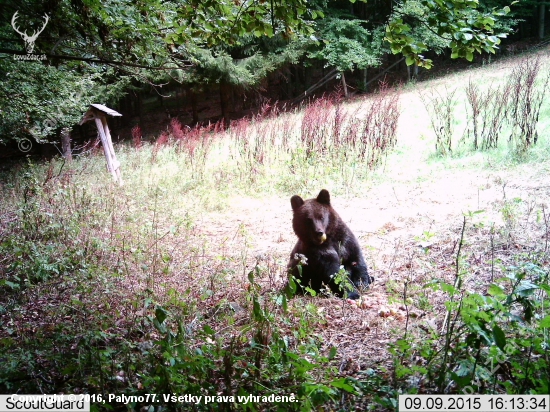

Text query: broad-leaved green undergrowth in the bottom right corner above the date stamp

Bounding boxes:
[390,214,550,395]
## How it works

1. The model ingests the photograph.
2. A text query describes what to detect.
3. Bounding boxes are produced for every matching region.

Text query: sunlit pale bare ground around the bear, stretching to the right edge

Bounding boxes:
[192,161,550,372]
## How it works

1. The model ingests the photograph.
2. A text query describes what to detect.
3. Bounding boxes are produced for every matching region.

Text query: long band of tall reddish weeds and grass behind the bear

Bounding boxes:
[139,88,399,194]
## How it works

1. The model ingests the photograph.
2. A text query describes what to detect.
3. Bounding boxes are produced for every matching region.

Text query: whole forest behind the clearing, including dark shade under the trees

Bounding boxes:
[0,0,547,155]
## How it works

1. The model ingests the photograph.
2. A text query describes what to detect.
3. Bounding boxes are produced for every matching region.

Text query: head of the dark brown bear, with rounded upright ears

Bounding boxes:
[290,189,336,245]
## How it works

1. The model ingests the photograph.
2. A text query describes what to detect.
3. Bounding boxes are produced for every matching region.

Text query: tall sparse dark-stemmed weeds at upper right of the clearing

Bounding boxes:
[422,56,550,155]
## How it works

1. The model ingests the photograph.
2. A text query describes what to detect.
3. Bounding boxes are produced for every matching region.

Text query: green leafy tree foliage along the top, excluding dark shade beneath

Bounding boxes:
[0,0,524,148]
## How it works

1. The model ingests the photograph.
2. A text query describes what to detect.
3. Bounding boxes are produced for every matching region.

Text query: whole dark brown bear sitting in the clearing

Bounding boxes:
[288,189,374,299]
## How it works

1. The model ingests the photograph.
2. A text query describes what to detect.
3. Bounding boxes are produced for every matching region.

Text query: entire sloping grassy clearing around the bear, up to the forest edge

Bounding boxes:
[0,50,550,411]
